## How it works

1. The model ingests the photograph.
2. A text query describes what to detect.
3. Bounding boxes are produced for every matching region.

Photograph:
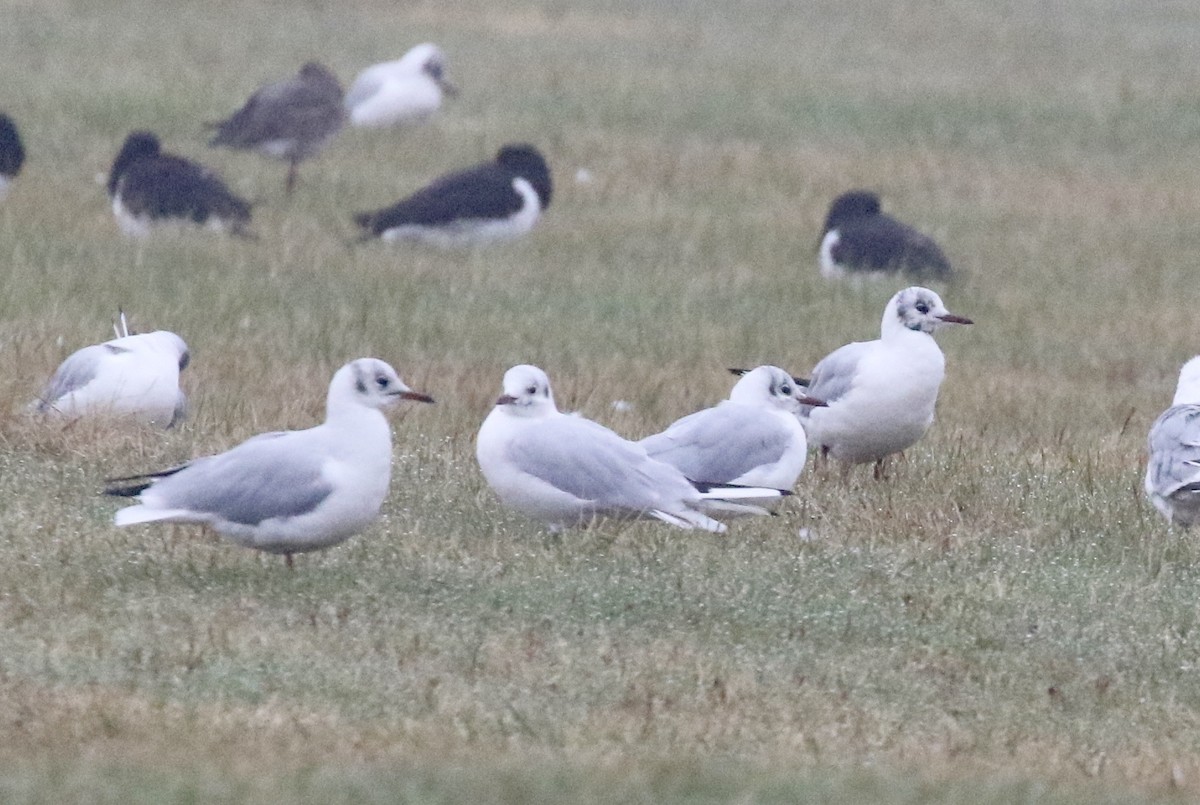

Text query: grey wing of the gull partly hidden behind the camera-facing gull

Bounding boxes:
[638,403,790,483]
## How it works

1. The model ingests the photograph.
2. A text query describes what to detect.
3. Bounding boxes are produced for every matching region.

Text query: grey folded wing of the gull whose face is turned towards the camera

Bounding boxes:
[509,416,688,511]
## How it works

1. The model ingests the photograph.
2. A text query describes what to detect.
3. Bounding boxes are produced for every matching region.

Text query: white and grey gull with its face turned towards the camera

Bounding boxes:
[475,365,788,531]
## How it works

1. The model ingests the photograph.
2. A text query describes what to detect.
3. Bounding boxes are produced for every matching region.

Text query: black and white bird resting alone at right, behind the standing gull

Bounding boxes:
[818,190,953,281]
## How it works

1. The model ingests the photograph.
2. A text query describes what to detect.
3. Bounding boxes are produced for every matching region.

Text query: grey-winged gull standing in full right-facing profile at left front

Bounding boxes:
[106,358,433,565]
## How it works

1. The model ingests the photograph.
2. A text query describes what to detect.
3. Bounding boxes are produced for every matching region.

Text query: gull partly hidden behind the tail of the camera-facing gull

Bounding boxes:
[638,366,824,489]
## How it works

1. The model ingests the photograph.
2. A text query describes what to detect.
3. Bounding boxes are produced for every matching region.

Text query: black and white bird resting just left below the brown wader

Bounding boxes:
[108,131,251,238]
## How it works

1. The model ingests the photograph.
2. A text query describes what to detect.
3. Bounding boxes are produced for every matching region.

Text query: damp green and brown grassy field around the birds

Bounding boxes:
[0,0,1200,804]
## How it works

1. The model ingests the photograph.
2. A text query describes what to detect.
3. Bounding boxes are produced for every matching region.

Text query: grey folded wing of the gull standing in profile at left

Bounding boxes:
[149,432,334,525]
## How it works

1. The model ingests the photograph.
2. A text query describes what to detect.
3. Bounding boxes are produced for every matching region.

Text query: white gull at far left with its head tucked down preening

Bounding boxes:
[30,314,190,427]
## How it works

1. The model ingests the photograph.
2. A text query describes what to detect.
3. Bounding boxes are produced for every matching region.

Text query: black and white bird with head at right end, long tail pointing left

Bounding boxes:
[354,145,552,247]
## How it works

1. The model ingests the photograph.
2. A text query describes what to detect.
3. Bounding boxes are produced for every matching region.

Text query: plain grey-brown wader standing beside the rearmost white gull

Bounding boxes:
[209,61,346,193]
